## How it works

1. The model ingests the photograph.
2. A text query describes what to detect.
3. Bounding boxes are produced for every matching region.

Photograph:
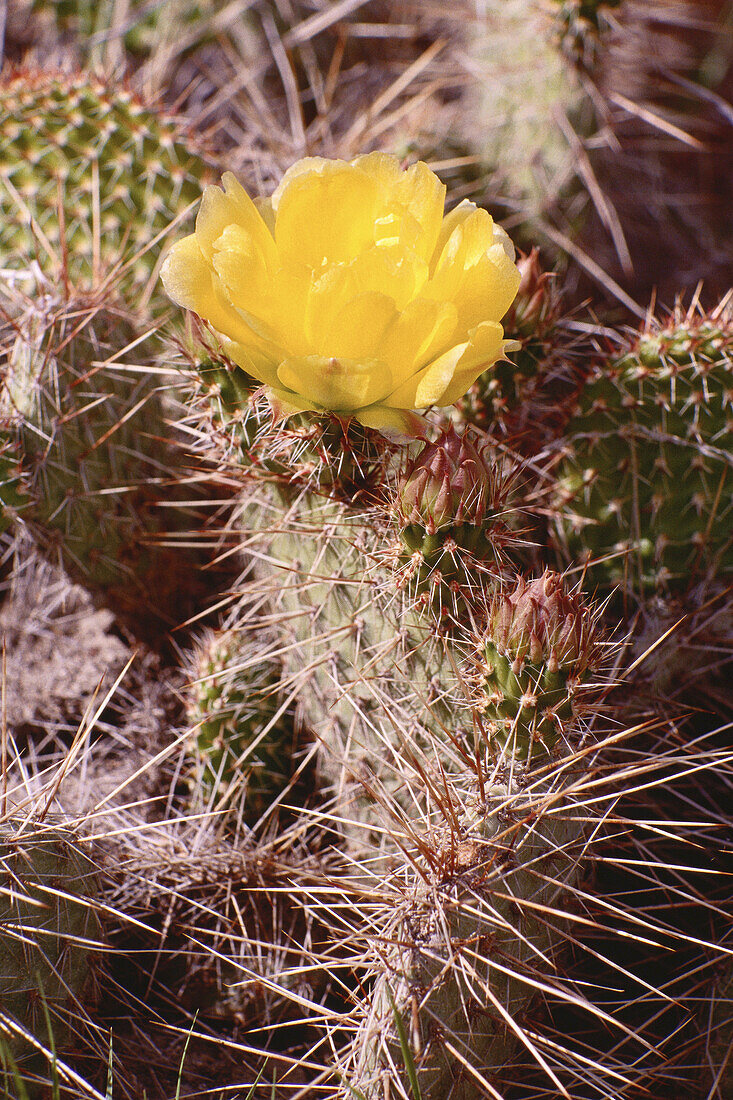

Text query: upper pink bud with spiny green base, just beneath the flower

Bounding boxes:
[397,426,515,591]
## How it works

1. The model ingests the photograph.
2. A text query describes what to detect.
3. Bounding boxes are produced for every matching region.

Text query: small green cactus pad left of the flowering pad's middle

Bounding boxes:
[188,630,305,825]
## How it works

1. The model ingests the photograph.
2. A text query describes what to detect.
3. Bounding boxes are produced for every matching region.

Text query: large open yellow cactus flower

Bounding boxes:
[162,153,519,435]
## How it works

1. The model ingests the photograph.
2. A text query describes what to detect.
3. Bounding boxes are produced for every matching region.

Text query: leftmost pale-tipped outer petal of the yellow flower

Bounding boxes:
[161,233,263,344]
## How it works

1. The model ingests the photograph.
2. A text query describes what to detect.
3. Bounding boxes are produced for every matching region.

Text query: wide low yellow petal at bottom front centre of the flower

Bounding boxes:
[277,355,392,411]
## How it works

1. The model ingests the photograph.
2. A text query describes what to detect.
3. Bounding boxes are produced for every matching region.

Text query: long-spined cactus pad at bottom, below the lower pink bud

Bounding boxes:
[339,776,580,1100]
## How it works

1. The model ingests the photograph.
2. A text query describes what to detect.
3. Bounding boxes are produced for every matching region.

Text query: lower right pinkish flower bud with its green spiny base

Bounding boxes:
[479,570,602,760]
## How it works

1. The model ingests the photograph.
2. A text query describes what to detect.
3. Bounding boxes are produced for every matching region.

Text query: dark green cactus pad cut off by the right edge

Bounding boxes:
[556,308,733,596]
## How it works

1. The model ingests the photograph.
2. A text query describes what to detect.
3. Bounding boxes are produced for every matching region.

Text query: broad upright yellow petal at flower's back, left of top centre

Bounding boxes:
[273,161,378,270]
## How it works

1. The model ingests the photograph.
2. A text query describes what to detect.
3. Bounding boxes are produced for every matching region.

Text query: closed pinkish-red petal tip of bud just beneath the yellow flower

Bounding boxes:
[400,426,502,535]
